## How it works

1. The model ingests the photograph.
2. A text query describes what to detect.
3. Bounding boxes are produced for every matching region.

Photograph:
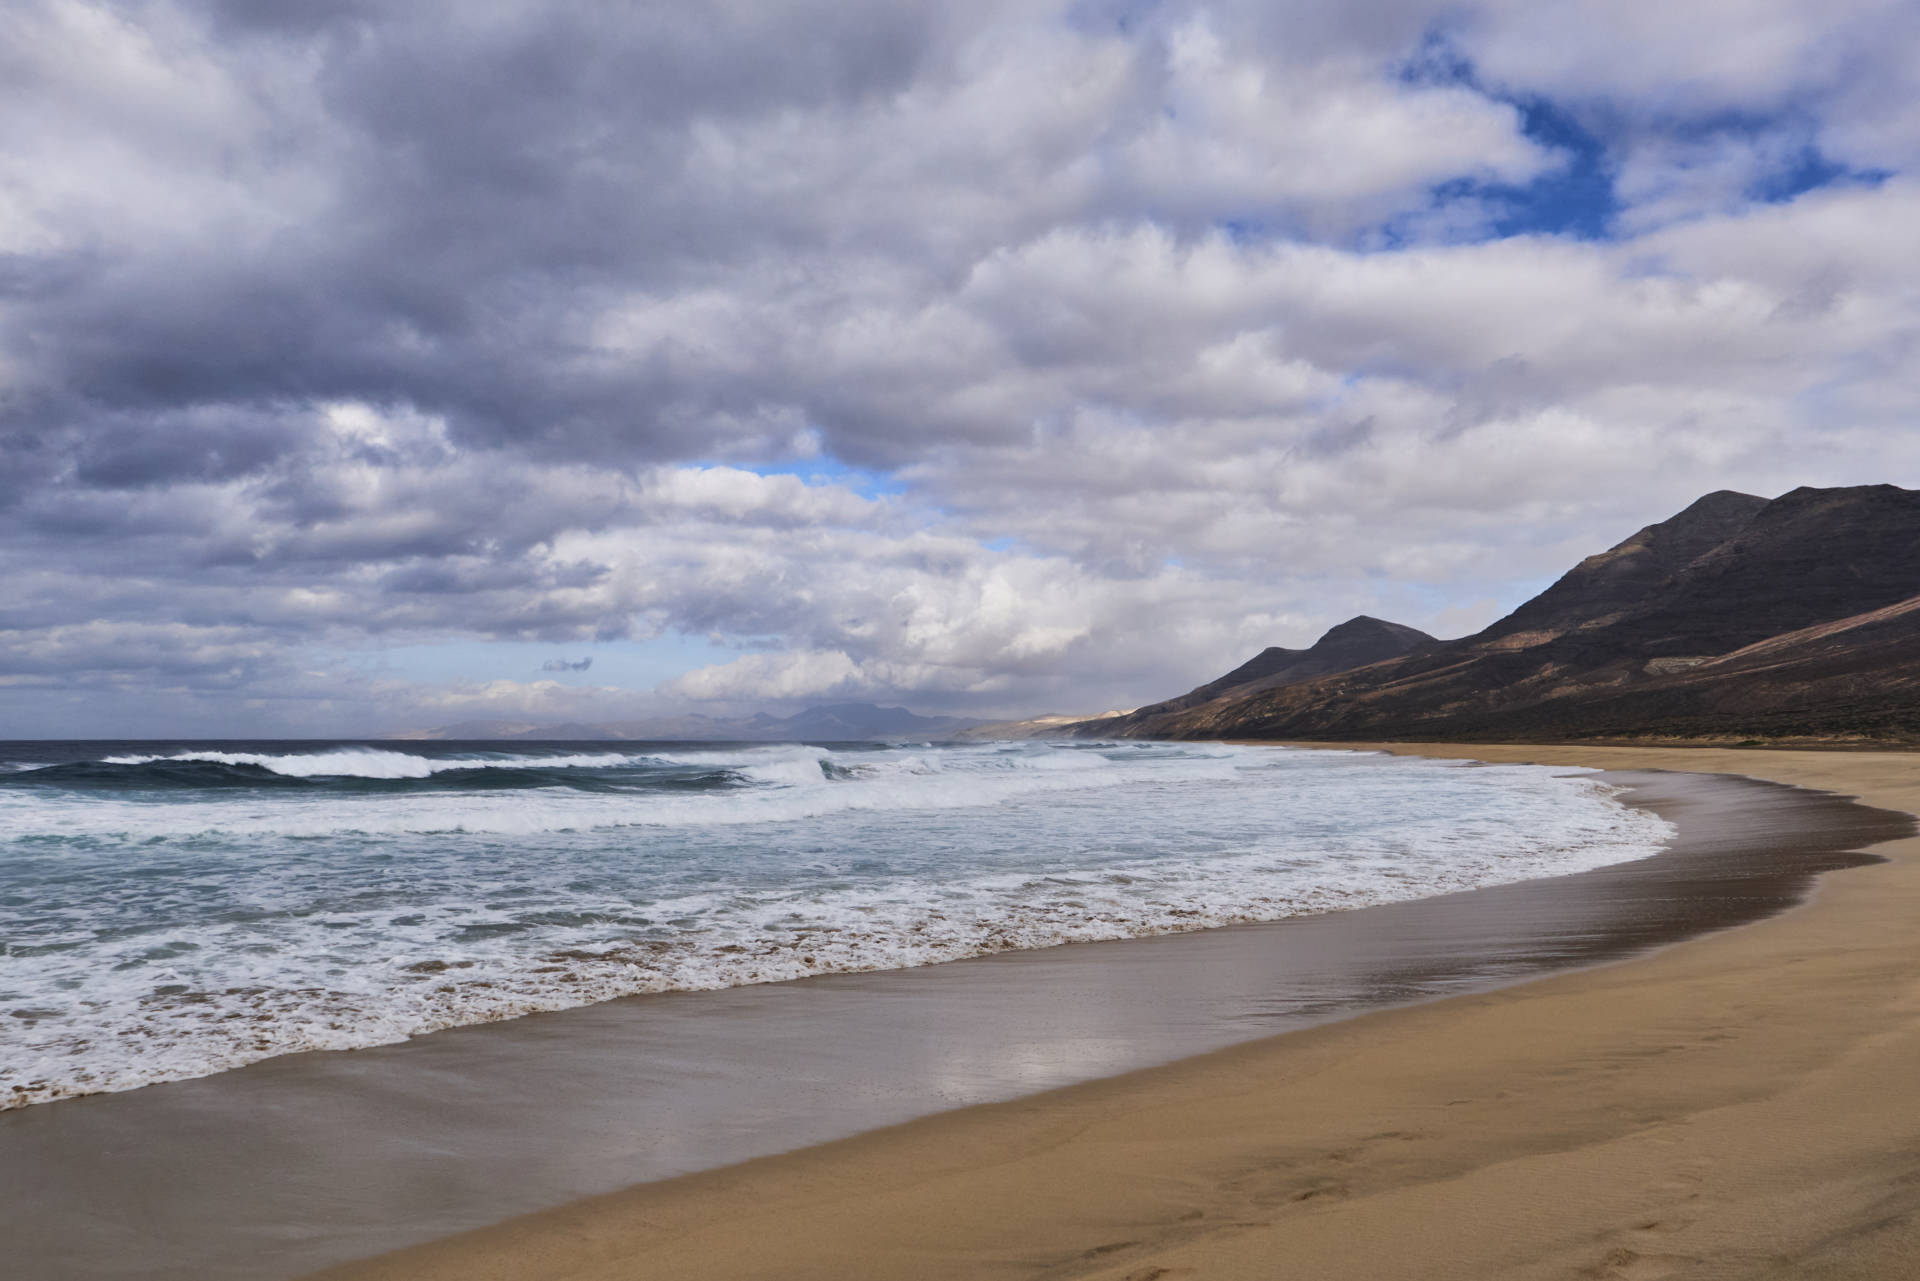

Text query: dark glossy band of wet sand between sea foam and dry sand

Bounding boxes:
[0,772,1910,1281]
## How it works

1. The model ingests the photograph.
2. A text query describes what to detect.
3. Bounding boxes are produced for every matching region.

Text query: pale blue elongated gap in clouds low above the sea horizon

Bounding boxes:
[328,632,739,689]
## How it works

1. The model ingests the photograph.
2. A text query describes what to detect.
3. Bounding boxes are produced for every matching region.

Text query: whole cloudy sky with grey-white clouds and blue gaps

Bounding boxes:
[0,0,1920,737]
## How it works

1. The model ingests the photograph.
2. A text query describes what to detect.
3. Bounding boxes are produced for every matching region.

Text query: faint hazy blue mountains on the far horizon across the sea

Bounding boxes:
[388,703,981,743]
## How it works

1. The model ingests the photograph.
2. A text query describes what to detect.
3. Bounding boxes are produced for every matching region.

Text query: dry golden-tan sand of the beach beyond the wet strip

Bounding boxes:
[324,745,1920,1281]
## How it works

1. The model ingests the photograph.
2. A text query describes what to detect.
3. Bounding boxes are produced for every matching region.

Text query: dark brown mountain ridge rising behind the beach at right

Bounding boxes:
[1056,486,1920,741]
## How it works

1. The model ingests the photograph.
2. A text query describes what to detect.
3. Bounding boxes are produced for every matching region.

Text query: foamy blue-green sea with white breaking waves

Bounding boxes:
[0,743,1670,1108]
